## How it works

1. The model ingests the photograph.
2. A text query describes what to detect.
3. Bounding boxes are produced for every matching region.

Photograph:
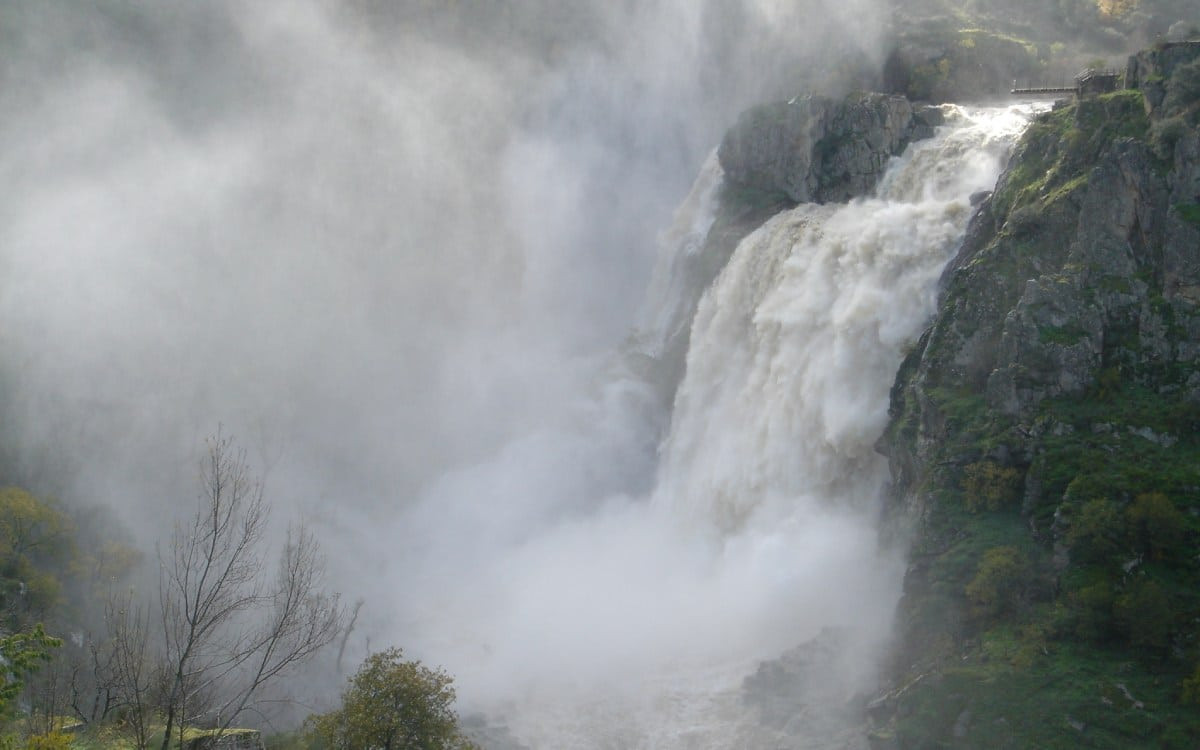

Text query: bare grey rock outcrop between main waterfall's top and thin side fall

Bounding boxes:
[718,94,941,203]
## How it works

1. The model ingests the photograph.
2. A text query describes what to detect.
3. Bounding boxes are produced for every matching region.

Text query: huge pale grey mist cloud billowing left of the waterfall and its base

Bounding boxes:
[0,0,902,744]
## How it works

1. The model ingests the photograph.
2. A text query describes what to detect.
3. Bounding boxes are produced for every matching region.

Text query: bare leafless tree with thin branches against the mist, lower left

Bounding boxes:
[158,432,344,750]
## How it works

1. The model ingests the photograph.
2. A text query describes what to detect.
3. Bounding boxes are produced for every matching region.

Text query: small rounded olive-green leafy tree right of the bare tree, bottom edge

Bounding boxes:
[308,648,473,750]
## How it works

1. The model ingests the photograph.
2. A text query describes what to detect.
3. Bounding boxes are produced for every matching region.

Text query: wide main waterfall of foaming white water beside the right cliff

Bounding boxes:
[656,107,1026,532]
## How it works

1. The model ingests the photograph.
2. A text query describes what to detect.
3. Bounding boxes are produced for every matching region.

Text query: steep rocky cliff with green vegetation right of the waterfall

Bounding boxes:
[872,43,1200,748]
